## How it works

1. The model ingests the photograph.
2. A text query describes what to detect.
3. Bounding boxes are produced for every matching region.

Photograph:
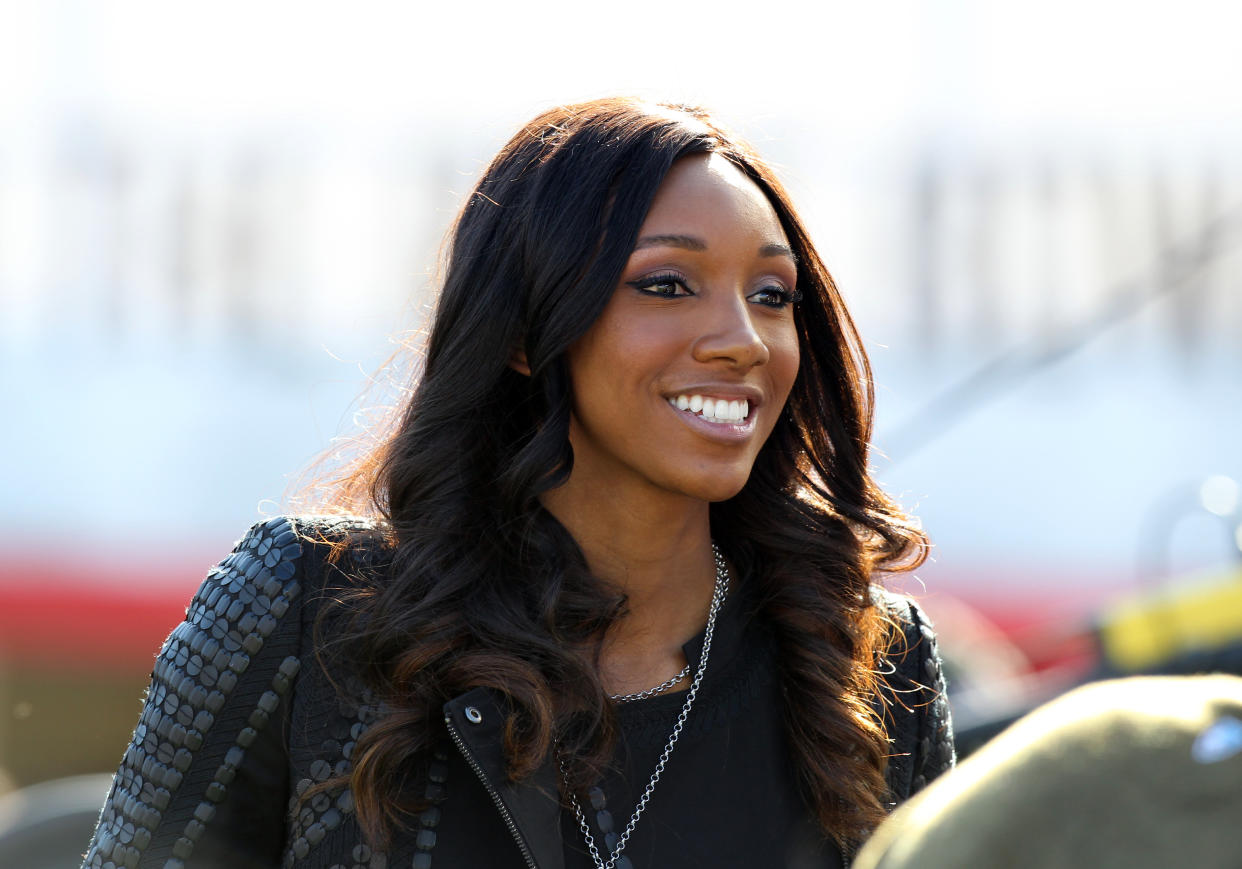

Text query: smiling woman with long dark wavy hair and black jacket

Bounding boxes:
[84,99,953,869]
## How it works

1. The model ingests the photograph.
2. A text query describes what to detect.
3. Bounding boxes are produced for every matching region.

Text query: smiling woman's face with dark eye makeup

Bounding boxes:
[569,154,799,502]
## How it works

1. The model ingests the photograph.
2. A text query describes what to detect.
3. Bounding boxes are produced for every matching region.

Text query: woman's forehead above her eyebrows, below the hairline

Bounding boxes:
[642,154,785,242]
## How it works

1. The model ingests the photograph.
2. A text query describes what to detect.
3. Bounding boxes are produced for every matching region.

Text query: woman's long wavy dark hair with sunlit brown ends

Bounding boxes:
[315,99,925,844]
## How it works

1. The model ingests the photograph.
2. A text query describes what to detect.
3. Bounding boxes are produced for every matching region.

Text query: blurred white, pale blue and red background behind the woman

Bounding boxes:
[0,0,1242,865]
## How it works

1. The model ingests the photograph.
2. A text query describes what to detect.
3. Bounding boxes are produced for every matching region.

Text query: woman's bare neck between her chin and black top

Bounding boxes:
[543,483,715,694]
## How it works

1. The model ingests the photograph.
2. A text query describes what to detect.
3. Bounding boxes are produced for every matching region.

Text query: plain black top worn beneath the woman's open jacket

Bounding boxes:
[561,571,842,869]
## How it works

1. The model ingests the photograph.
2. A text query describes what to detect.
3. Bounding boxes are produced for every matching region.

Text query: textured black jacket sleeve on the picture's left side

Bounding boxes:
[82,518,310,869]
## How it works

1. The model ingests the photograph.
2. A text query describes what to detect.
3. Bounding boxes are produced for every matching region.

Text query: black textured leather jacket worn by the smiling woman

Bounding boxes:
[83,518,954,869]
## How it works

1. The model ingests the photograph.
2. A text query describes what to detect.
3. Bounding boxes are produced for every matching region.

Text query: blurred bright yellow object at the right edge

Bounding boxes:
[1098,569,1242,673]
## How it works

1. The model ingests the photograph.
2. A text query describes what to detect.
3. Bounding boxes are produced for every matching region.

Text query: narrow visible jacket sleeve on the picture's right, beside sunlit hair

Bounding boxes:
[877,592,956,804]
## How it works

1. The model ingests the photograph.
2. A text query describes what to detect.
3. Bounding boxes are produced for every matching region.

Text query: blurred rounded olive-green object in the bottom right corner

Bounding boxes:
[854,674,1242,869]
